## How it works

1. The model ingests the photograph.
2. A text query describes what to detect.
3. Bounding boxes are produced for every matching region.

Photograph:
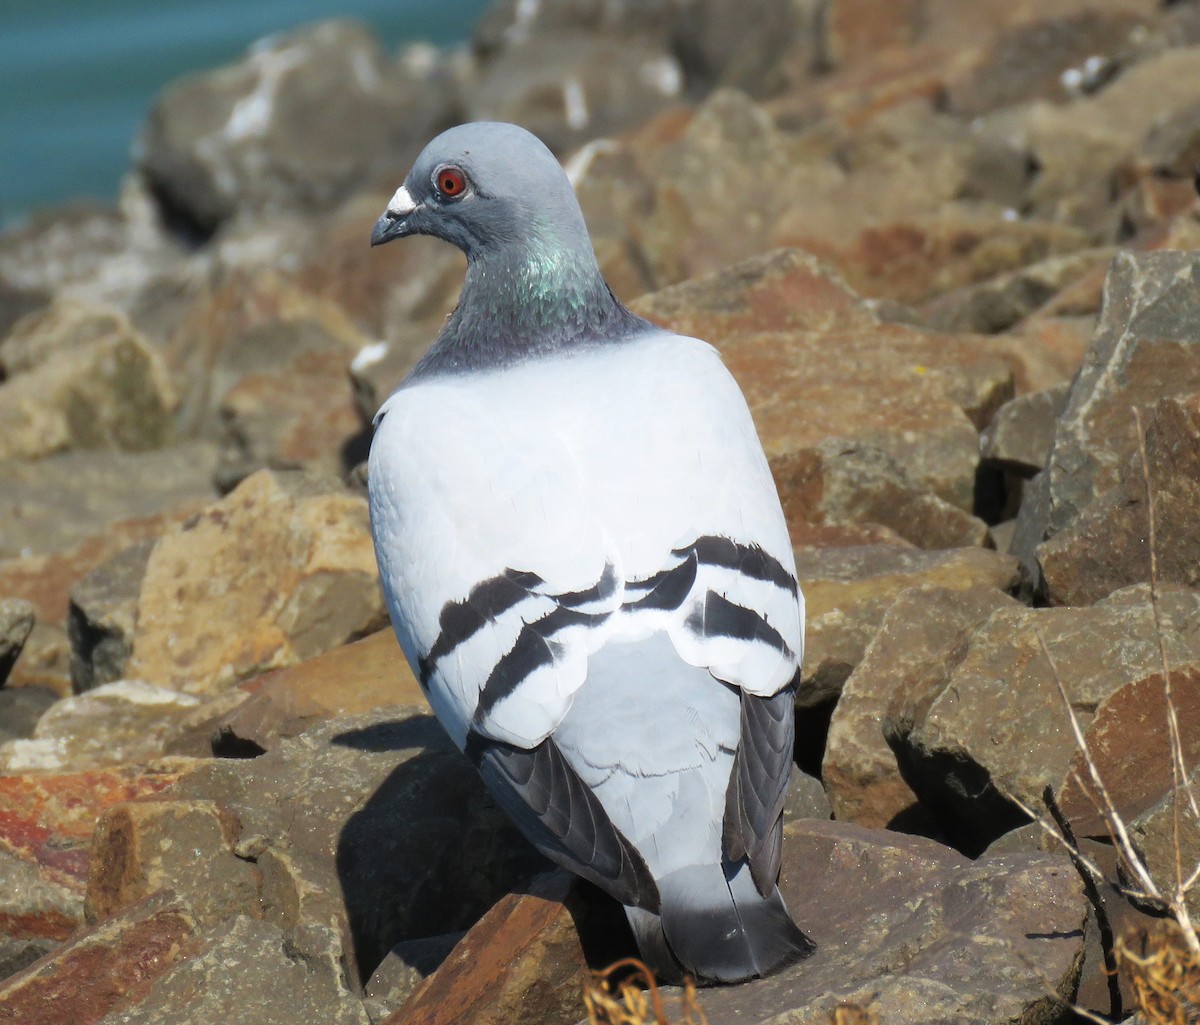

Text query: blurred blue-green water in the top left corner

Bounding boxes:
[0,0,487,223]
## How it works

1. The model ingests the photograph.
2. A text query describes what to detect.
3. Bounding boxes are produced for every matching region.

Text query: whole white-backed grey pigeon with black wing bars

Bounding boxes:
[367,122,814,983]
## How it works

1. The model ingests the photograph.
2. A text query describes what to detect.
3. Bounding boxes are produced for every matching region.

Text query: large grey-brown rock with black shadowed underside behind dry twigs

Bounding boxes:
[884,586,1200,851]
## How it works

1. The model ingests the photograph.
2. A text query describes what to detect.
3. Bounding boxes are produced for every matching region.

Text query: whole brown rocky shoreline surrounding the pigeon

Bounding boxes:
[0,0,1200,1025]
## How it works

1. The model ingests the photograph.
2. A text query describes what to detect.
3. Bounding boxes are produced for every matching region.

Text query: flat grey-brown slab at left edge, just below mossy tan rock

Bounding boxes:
[0,442,217,561]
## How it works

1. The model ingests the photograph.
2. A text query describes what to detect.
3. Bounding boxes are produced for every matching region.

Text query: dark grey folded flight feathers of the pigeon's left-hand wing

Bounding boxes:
[467,733,659,911]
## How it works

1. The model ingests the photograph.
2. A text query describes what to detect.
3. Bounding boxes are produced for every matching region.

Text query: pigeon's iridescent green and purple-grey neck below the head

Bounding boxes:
[413,235,644,377]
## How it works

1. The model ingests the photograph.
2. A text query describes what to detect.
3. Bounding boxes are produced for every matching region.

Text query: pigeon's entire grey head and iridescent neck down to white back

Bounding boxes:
[371,121,648,377]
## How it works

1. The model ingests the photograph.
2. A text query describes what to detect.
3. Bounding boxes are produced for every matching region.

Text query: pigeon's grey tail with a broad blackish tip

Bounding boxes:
[625,862,816,982]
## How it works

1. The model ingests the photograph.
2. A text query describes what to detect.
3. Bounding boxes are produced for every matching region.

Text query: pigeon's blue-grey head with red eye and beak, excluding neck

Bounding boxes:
[371,121,590,258]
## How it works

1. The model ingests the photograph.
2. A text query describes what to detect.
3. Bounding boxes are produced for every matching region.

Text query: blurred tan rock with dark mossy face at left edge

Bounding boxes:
[0,331,179,458]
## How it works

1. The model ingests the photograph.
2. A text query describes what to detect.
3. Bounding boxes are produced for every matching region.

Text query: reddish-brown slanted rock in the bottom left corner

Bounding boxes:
[0,893,202,1025]
